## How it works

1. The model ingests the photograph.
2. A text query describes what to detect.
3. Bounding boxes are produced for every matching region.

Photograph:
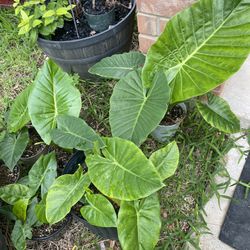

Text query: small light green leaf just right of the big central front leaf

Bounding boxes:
[149,141,179,180]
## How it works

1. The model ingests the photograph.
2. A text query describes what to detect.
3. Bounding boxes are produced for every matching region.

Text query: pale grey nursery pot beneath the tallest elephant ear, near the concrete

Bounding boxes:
[151,103,187,143]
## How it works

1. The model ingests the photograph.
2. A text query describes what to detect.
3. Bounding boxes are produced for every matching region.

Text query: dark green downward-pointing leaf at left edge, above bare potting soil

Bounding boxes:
[0,129,29,170]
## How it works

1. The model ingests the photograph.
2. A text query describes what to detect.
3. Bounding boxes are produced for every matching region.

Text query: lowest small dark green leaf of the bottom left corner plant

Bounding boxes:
[11,220,32,250]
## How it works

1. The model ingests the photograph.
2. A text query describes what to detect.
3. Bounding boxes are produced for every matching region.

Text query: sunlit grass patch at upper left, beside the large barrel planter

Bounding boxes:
[0,9,44,113]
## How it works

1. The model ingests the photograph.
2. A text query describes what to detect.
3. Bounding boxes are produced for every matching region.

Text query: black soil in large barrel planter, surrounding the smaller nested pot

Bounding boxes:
[51,0,132,41]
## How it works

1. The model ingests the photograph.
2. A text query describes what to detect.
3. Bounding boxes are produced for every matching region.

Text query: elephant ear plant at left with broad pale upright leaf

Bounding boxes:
[0,60,81,170]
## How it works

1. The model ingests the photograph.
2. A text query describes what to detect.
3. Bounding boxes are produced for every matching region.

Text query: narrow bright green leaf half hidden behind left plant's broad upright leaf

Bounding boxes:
[7,85,33,133]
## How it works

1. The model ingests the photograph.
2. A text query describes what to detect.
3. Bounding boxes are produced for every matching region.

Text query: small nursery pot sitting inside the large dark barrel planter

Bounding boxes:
[84,7,115,32]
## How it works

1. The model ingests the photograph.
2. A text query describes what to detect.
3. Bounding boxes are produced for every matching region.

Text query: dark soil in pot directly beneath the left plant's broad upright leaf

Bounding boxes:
[22,128,46,158]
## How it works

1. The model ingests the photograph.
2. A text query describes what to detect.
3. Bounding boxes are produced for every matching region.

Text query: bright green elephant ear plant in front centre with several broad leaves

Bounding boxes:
[43,116,179,250]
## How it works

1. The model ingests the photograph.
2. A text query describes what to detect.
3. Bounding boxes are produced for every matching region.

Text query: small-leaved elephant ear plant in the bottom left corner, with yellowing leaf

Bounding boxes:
[0,152,57,250]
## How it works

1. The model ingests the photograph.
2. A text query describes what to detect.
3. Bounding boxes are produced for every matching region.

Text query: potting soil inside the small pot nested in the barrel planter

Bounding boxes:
[83,0,114,15]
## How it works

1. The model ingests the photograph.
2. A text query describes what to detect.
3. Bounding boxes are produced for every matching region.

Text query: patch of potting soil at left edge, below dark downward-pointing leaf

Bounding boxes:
[0,163,19,187]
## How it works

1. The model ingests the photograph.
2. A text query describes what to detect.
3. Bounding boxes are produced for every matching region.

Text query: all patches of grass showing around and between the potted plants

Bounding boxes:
[0,10,238,250]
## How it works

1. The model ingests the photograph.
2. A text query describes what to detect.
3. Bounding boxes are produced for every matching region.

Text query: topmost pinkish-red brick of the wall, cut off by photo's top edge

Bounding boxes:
[137,0,195,17]
